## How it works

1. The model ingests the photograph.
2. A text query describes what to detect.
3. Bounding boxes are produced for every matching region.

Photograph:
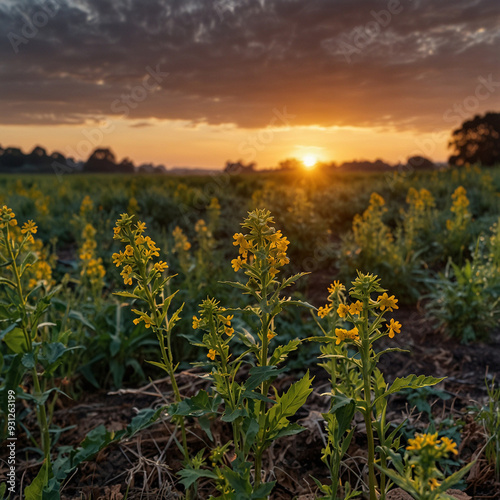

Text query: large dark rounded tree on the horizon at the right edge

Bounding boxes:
[448,113,500,166]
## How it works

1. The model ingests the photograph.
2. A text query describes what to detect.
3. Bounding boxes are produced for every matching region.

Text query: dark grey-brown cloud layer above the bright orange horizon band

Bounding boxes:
[0,0,500,129]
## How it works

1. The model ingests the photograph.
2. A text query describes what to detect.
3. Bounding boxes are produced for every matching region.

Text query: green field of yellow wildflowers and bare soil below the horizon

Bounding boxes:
[0,167,500,500]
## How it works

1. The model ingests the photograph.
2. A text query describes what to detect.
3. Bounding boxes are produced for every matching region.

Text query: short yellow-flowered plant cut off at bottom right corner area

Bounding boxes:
[381,432,474,500]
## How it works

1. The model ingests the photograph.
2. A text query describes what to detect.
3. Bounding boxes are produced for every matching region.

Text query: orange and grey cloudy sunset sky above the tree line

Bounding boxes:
[0,0,500,168]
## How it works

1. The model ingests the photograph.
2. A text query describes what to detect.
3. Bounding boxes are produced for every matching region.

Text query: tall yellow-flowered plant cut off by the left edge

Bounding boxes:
[0,206,75,499]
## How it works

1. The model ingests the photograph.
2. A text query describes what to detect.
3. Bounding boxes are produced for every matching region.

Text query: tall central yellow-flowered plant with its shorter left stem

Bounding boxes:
[179,210,312,499]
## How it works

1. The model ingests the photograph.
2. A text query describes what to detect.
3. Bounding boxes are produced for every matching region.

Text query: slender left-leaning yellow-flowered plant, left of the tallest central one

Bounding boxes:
[113,214,189,461]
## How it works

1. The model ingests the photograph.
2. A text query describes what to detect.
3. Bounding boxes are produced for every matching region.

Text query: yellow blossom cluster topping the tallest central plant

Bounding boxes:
[231,211,290,278]
